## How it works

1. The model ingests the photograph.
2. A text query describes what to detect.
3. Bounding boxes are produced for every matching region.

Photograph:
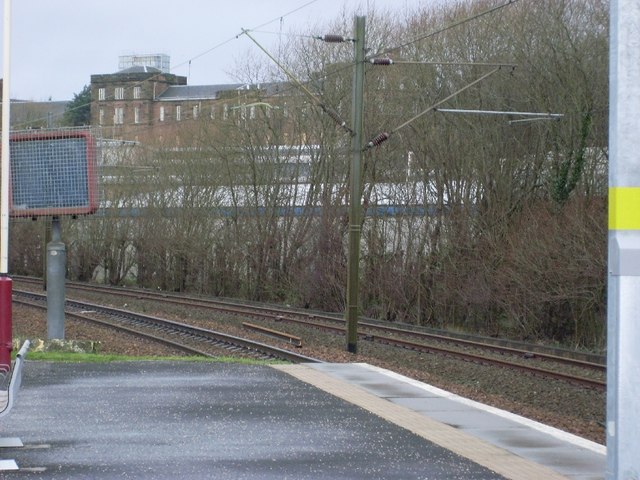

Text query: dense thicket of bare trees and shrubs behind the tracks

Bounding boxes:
[26,0,608,346]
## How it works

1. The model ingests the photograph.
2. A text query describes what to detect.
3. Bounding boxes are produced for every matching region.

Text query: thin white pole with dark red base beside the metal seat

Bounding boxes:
[0,0,13,368]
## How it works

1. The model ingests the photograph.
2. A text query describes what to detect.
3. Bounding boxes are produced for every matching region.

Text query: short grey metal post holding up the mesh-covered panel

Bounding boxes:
[47,217,67,340]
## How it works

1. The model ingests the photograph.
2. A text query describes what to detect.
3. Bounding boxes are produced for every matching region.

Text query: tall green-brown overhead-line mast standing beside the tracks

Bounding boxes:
[345,17,366,353]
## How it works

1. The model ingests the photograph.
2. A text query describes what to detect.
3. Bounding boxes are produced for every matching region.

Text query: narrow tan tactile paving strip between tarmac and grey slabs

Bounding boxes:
[273,365,567,480]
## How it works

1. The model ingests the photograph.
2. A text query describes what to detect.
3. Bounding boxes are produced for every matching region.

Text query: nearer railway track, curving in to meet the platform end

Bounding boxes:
[13,290,320,363]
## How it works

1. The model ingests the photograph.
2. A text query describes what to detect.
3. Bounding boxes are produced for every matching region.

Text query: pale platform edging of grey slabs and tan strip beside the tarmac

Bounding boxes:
[292,364,606,480]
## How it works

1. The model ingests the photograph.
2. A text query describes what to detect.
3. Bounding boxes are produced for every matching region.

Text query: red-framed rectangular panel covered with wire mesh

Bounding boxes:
[9,129,98,217]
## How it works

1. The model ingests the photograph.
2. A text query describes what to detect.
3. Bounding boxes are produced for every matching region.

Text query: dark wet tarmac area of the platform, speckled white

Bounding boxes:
[0,362,502,480]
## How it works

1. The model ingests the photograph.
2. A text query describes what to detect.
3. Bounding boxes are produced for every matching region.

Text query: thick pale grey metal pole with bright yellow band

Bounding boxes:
[607,0,640,480]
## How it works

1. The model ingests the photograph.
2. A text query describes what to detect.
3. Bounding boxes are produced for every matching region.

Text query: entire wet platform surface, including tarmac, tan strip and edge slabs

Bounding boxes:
[0,362,605,480]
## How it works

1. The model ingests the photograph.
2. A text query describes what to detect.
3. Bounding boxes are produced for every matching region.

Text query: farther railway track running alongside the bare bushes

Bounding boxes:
[13,277,606,390]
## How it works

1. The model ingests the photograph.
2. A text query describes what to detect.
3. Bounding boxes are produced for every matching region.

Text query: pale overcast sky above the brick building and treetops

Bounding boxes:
[0,0,433,101]
